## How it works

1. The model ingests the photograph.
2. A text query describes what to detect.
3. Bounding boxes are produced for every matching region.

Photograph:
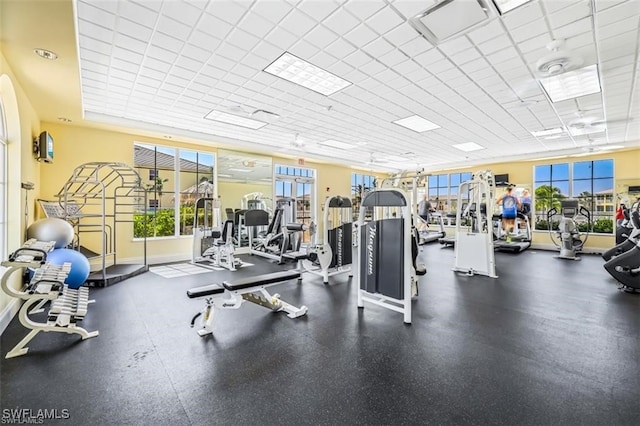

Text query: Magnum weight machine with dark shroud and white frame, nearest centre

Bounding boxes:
[354,188,426,324]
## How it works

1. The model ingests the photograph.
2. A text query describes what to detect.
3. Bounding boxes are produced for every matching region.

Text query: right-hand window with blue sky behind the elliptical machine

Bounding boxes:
[534,159,615,233]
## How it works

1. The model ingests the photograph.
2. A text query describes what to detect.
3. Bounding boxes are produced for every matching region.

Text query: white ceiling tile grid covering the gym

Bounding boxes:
[78,0,640,173]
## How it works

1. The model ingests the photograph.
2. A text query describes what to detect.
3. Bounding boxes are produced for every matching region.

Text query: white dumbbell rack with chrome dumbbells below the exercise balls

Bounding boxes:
[0,239,99,358]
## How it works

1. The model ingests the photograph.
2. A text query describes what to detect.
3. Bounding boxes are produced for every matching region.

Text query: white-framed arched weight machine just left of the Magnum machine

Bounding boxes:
[303,195,354,284]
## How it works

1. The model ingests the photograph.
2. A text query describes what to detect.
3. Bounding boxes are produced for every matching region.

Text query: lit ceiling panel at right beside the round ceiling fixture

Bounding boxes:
[540,65,600,102]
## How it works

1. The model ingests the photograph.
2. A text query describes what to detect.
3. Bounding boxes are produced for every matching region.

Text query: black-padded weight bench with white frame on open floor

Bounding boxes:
[187,270,307,336]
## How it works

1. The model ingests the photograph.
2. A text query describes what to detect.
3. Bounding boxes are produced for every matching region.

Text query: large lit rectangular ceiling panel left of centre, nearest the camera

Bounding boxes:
[264,52,351,96]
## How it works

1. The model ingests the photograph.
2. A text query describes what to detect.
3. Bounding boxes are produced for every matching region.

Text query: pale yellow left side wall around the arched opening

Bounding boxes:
[0,52,40,313]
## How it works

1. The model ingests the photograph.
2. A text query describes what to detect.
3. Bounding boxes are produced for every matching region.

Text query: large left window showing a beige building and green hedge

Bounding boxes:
[134,142,215,237]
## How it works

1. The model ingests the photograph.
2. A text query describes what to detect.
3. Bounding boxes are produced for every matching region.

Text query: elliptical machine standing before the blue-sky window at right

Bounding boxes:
[547,200,591,260]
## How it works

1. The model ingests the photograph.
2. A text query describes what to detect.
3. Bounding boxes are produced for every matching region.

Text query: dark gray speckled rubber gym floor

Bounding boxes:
[0,244,640,425]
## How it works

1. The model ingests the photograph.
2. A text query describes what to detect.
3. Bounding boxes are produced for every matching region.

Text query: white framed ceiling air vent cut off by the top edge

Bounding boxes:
[409,0,498,46]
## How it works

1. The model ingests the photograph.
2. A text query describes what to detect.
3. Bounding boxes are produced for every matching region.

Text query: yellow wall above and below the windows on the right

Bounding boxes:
[429,149,640,251]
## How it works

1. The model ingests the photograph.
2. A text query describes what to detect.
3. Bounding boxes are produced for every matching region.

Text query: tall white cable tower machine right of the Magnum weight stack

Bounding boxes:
[452,170,498,278]
